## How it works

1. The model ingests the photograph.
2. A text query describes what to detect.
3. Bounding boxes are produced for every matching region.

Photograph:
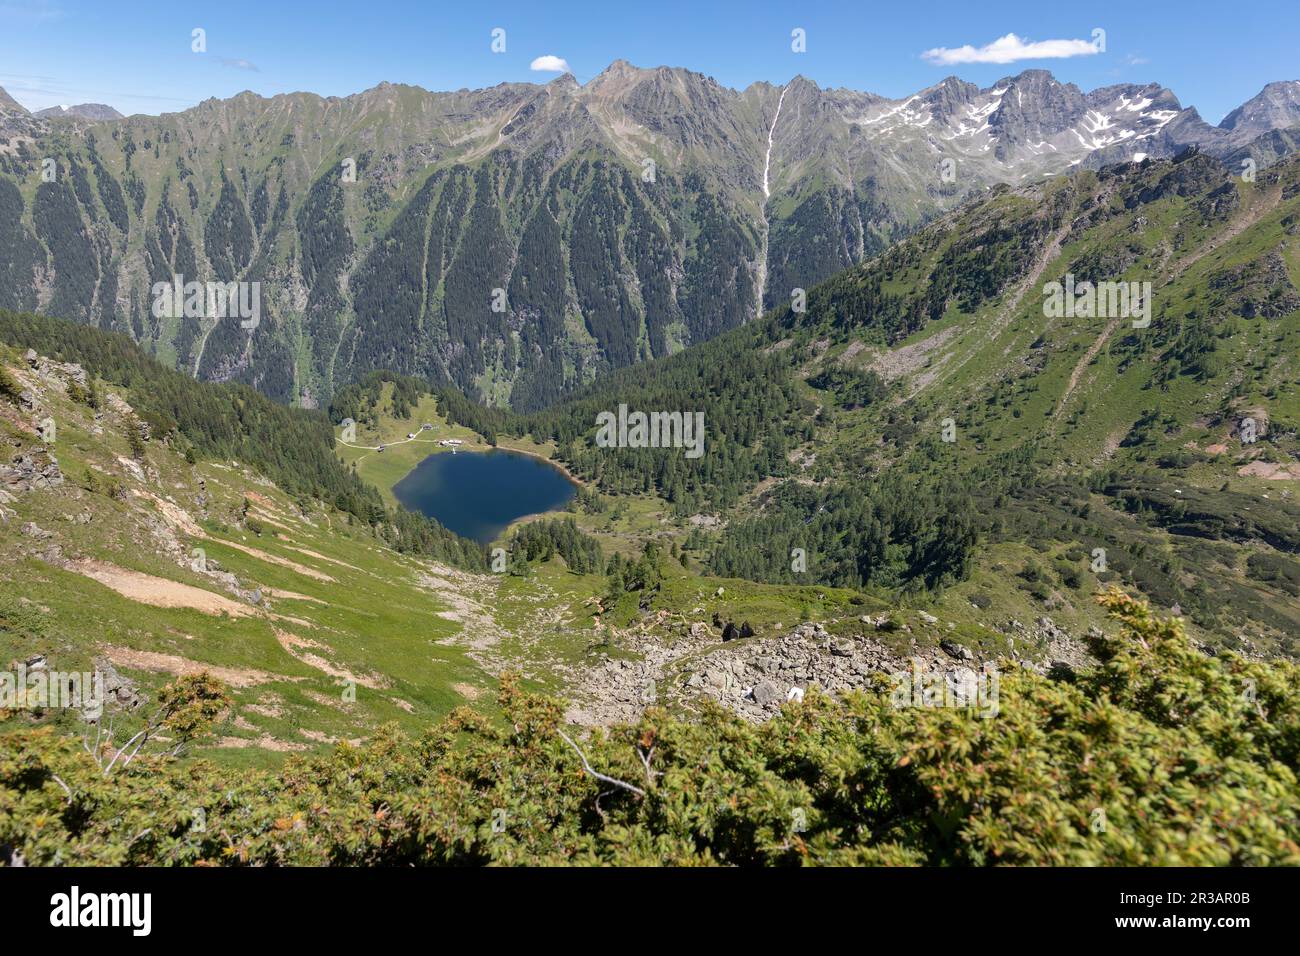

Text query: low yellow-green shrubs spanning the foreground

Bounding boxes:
[0,591,1300,865]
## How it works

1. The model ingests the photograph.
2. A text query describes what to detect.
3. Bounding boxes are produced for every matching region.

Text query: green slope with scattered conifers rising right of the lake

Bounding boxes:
[405,151,1300,653]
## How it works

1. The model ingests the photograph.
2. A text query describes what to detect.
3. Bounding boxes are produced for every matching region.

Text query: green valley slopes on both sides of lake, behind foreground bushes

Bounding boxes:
[0,152,1300,790]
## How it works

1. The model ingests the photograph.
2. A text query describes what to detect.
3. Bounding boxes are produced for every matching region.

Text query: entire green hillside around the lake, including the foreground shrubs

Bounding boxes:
[0,152,1300,865]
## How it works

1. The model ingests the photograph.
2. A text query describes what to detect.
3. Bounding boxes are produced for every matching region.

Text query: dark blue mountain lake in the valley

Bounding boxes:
[393,450,577,544]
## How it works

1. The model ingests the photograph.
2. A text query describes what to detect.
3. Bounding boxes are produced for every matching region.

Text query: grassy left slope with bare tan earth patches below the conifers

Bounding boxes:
[0,316,961,749]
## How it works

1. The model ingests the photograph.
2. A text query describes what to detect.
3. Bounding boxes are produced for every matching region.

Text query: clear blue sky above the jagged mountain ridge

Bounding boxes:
[0,0,1300,122]
